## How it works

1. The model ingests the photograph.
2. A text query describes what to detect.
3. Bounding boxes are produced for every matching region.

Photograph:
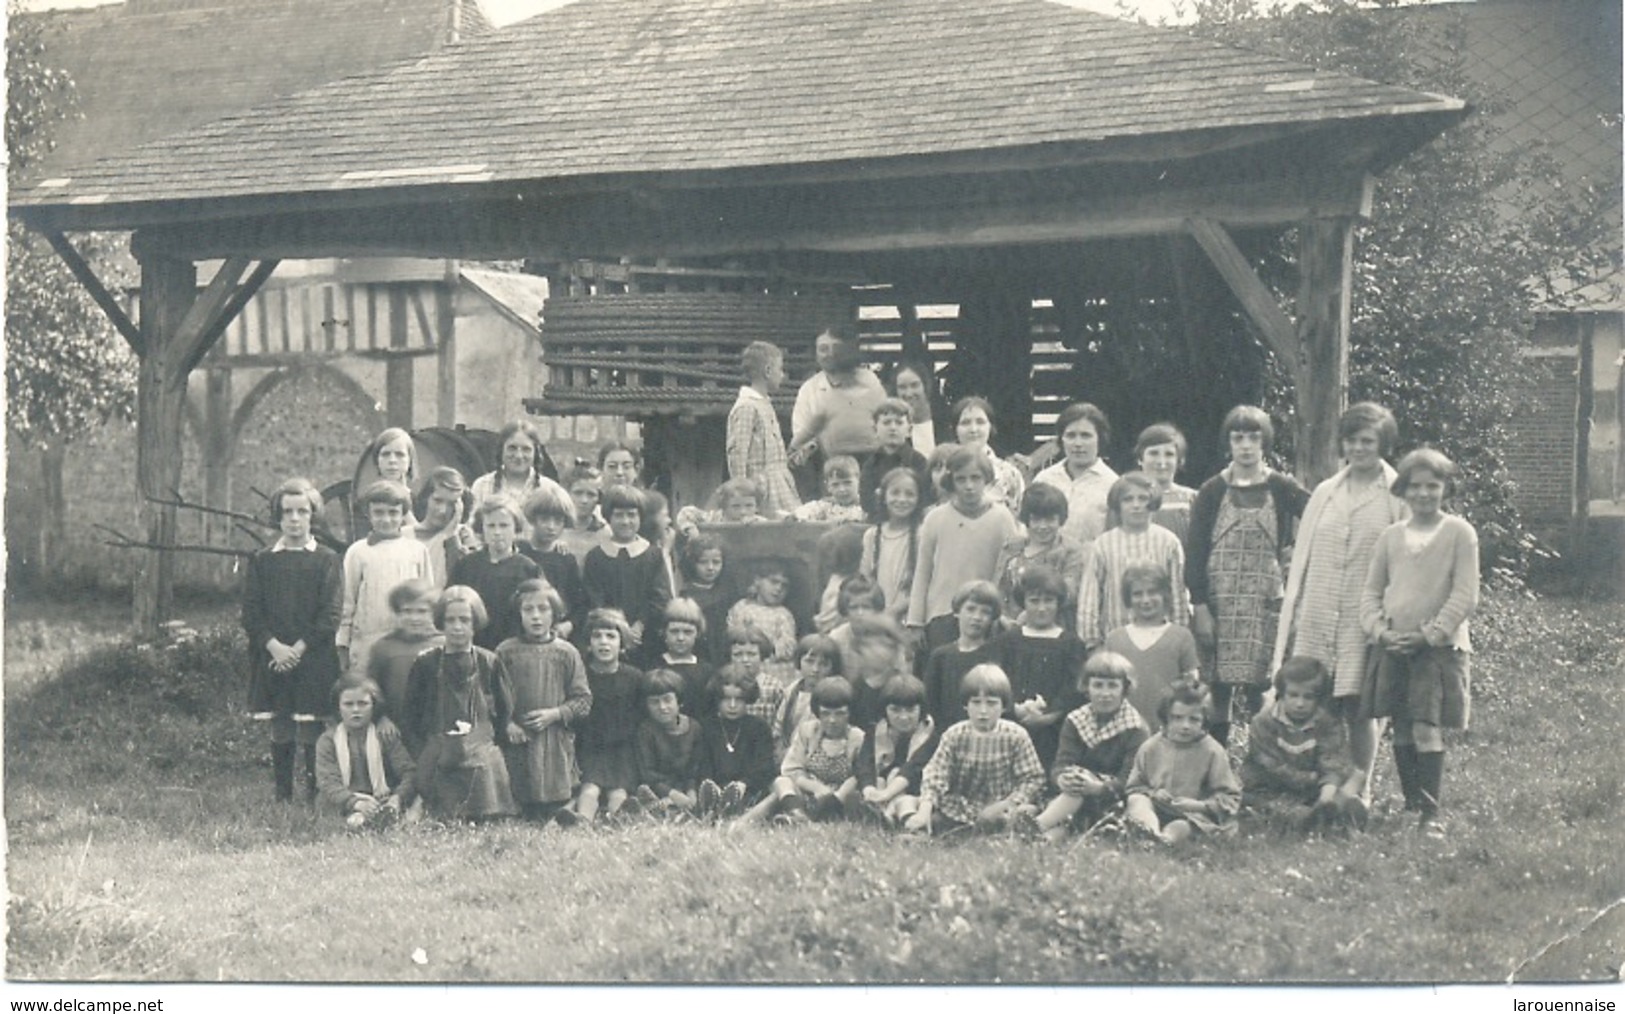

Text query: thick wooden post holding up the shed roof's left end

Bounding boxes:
[135,257,198,635]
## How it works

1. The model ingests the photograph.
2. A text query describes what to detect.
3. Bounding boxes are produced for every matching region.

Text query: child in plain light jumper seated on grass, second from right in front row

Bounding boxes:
[1126,684,1242,845]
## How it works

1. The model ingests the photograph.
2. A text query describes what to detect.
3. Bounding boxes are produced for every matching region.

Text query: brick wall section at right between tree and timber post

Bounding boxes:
[1506,349,1580,523]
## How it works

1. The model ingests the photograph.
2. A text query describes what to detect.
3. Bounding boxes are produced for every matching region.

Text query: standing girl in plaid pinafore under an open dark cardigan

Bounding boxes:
[1185,405,1310,744]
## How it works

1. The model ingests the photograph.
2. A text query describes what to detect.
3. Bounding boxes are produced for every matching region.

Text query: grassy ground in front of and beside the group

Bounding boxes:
[5,585,1625,983]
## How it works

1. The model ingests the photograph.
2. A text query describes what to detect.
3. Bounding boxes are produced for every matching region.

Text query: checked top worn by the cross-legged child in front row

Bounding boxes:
[920,718,1043,824]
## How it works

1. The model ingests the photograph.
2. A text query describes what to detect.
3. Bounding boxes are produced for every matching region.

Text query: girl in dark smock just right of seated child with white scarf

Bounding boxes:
[405,585,518,821]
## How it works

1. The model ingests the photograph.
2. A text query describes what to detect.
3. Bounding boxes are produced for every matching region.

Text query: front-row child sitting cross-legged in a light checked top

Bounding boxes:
[904,663,1043,834]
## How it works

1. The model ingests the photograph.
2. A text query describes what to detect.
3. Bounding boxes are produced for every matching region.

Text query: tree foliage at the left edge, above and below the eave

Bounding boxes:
[5,10,135,449]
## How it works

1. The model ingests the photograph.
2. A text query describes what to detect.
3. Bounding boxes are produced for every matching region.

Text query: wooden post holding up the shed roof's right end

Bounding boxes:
[1295,216,1354,488]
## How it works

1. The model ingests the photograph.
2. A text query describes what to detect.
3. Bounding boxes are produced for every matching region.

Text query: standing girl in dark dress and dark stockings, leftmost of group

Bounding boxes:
[242,479,345,803]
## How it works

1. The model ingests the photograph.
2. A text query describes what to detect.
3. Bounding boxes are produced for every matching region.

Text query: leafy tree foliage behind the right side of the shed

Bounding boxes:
[1193,0,1619,575]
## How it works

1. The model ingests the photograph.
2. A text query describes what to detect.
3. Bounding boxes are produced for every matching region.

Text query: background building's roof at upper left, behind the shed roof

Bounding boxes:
[20,0,491,177]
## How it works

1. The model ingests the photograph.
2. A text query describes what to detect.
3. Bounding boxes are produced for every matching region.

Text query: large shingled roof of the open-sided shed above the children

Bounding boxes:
[13,0,1461,205]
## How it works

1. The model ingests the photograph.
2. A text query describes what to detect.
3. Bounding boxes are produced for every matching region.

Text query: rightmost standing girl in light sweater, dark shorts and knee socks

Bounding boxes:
[1360,447,1479,837]
